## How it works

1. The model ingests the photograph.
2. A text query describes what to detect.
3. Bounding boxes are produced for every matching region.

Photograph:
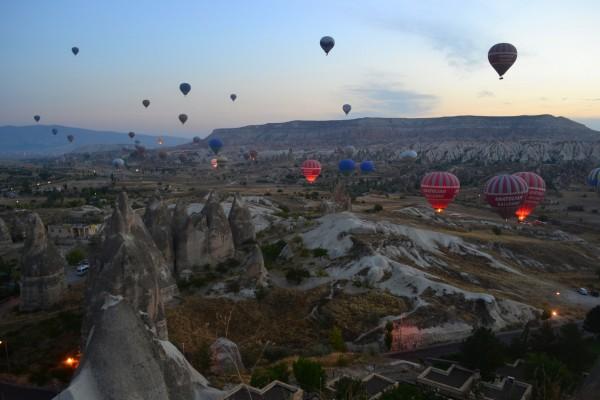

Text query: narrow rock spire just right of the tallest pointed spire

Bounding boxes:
[144,197,174,272]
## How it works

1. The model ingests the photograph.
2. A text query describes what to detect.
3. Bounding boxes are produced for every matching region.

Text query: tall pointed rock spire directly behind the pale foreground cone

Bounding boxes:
[83,193,177,339]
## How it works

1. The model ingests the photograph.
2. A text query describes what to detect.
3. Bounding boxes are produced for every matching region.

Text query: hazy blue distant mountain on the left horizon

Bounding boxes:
[0,125,190,158]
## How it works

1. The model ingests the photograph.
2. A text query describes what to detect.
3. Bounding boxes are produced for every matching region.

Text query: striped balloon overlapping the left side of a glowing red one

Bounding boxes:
[483,175,528,219]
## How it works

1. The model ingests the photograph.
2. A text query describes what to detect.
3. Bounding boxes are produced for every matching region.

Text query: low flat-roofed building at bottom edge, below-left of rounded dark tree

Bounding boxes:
[417,364,479,400]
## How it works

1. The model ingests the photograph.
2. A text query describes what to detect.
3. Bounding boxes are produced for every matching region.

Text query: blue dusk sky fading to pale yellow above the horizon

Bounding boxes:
[0,0,600,137]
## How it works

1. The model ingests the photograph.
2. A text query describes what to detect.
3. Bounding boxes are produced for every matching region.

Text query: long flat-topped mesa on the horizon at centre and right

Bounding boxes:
[208,114,600,148]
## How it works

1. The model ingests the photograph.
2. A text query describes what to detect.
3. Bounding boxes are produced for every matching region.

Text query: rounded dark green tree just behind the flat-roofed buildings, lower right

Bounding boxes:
[461,328,504,379]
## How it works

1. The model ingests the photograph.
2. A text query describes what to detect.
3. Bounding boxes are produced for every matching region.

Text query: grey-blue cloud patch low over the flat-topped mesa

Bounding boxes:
[349,83,439,116]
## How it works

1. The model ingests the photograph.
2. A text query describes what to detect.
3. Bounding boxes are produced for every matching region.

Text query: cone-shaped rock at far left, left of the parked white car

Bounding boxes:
[21,213,66,311]
